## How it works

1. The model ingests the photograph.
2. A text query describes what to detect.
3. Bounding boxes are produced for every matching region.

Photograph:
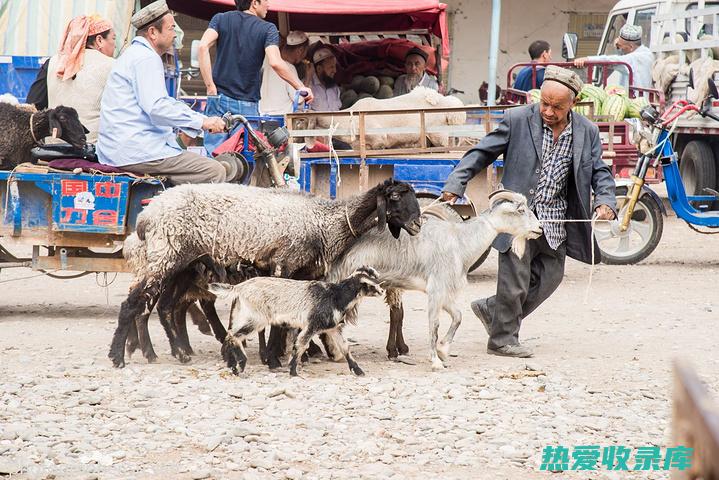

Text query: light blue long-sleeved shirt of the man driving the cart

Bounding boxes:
[97,37,206,167]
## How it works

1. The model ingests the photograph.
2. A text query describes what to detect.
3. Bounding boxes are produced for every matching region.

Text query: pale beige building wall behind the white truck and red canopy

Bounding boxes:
[443,0,616,103]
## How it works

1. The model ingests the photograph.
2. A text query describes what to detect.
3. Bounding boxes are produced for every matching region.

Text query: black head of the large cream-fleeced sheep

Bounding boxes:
[377,179,421,238]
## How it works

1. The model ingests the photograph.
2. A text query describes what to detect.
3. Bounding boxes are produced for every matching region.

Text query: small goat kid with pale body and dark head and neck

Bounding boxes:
[209,267,384,376]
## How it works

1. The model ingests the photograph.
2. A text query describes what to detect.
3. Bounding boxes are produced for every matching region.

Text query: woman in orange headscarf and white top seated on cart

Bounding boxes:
[27,15,115,143]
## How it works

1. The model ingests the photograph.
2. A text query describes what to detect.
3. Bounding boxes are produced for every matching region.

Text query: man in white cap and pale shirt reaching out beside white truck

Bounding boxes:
[574,24,654,88]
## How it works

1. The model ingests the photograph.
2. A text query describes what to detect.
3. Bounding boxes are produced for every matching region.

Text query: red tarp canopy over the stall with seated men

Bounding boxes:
[167,0,449,58]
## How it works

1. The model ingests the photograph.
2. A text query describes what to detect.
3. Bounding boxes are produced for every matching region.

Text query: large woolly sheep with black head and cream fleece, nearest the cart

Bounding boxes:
[109,180,420,367]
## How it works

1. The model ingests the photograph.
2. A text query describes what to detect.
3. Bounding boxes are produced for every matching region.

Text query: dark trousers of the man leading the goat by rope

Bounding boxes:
[487,236,566,349]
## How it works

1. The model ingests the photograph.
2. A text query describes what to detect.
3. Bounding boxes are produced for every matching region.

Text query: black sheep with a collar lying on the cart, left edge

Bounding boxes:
[0,103,87,170]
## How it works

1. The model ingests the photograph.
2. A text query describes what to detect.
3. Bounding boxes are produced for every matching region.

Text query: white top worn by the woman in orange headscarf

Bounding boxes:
[47,48,115,143]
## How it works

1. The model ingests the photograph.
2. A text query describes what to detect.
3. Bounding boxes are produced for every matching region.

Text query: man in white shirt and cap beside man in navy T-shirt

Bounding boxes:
[260,30,310,115]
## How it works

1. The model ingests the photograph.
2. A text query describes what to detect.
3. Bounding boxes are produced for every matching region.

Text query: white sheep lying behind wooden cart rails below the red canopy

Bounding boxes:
[317,87,467,149]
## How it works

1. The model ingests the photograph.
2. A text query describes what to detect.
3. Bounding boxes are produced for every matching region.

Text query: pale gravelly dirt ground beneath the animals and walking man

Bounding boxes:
[0,217,719,479]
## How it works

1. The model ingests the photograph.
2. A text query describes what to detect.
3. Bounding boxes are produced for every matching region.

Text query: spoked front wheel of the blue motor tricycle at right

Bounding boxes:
[594,187,664,265]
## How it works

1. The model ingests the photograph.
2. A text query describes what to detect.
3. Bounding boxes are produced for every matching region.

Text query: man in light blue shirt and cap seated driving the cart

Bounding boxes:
[97,0,226,184]
